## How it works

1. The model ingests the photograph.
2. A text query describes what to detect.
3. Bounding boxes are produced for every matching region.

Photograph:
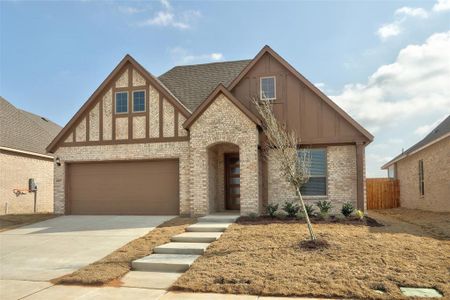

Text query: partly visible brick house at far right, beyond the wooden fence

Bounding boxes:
[382,116,450,211]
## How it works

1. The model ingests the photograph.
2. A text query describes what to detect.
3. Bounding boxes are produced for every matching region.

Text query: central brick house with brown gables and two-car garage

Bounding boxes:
[47,46,373,215]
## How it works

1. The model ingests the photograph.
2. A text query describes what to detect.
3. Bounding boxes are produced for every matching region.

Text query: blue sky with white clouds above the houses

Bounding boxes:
[0,0,450,177]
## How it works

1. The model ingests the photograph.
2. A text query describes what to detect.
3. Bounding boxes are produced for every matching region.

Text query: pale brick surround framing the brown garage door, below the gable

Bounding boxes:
[54,142,190,215]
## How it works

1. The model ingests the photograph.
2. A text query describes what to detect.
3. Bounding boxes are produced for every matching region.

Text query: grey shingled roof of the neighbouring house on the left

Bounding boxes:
[0,97,61,154]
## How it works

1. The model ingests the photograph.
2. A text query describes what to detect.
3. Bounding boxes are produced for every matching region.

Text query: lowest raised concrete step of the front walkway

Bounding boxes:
[131,254,200,272]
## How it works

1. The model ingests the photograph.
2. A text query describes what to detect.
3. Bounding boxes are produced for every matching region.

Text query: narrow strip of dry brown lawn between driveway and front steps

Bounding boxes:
[52,217,196,285]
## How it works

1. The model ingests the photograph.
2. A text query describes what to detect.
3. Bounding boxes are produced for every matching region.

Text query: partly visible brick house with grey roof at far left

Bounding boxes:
[0,97,61,214]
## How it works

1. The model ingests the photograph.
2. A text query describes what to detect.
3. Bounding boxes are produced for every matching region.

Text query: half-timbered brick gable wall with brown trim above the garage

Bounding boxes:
[61,64,188,147]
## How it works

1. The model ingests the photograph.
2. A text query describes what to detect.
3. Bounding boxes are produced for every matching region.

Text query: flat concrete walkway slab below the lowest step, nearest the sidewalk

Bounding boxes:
[120,271,182,290]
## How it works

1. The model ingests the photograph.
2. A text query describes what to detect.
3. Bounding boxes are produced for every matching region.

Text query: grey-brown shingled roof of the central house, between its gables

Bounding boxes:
[158,59,251,111]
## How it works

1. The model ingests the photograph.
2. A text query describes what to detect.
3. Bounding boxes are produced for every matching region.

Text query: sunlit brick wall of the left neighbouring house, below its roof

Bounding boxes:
[0,151,53,215]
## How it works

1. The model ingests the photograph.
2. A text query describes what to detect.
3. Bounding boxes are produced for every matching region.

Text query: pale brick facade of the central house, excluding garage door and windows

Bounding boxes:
[54,64,368,215]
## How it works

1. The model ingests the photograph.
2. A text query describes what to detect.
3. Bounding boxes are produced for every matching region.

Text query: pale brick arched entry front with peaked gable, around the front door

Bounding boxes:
[190,94,261,215]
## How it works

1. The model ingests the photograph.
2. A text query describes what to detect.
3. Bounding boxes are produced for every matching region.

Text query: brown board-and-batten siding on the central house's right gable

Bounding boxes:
[231,53,367,144]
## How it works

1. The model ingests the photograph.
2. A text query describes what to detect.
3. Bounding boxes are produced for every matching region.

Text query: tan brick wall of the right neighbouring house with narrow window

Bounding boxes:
[396,137,450,212]
